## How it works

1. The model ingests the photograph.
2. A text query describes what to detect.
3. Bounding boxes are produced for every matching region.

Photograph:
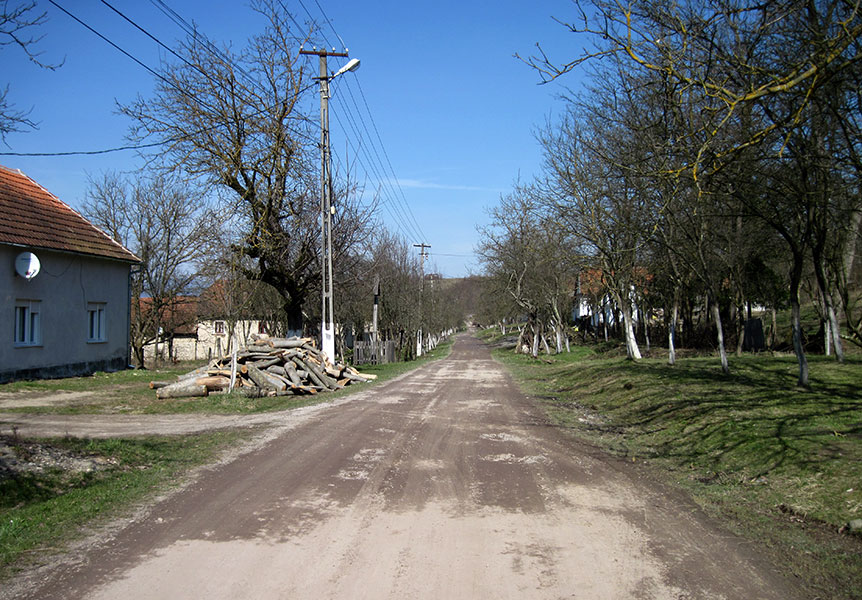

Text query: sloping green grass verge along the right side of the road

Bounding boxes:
[495,347,862,598]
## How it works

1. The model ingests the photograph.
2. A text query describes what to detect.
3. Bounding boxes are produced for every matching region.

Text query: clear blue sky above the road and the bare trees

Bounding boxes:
[0,0,580,277]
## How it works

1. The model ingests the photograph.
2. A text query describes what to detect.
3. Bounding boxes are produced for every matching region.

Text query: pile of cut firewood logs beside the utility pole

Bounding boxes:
[150,337,377,398]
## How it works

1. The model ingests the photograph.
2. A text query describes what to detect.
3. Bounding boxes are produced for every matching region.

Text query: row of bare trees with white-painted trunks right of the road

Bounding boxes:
[481,0,862,386]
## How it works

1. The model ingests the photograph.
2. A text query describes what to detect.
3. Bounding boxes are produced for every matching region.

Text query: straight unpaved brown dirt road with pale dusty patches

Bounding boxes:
[5,337,797,600]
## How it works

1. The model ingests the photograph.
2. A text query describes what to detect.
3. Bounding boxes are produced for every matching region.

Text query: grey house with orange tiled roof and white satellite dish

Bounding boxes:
[0,166,140,381]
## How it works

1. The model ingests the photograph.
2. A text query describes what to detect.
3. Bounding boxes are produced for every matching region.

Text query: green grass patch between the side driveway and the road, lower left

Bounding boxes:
[0,431,249,579]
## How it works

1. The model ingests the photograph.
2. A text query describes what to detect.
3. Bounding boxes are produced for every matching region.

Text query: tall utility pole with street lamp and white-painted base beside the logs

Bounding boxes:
[299,49,359,362]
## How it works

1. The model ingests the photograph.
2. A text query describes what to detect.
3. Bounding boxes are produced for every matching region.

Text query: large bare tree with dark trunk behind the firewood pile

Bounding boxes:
[121,0,367,333]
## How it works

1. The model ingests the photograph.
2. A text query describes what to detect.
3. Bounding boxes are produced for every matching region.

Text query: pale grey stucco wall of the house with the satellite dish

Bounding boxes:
[0,245,130,380]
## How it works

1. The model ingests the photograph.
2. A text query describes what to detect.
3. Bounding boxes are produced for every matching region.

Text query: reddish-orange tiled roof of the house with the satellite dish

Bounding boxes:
[0,165,140,262]
